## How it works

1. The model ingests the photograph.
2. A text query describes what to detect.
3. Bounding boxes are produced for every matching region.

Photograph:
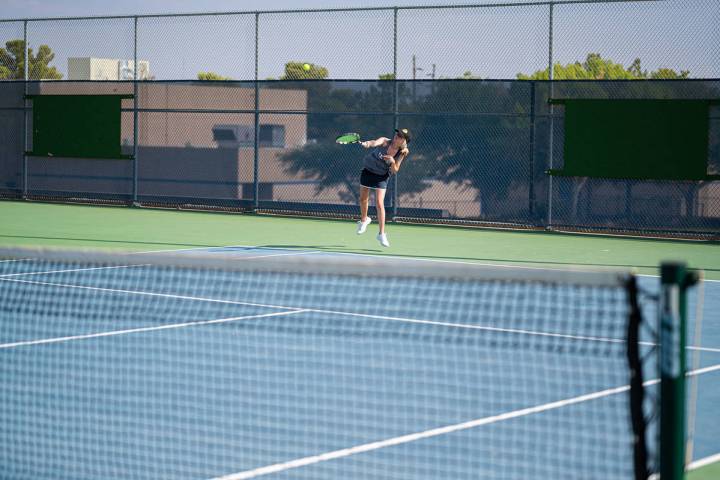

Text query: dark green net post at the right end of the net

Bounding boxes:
[658,262,697,480]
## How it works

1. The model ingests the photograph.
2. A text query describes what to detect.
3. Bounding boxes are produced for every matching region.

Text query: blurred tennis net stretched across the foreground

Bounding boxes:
[0,249,651,480]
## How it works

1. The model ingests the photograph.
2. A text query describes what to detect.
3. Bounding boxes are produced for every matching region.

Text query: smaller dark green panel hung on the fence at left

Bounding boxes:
[27,95,133,158]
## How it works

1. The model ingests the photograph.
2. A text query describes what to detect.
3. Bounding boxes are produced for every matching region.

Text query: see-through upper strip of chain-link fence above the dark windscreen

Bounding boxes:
[0,0,720,80]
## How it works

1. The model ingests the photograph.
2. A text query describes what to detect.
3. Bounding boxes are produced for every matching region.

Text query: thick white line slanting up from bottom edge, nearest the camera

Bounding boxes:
[215,364,720,480]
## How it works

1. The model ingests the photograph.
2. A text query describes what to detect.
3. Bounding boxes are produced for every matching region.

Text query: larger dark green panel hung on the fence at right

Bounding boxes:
[548,99,716,180]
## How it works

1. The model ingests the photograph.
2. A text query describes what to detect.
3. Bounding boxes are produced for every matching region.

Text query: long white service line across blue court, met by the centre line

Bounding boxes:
[0,278,720,353]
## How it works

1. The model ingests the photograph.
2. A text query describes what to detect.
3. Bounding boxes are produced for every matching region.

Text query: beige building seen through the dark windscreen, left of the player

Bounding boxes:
[23,82,484,217]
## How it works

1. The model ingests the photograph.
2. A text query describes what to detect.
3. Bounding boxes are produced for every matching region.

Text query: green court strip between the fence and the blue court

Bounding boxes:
[0,202,720,280]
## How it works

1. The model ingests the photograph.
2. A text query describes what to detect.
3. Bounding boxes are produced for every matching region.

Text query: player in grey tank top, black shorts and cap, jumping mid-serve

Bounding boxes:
[357,128,410,247]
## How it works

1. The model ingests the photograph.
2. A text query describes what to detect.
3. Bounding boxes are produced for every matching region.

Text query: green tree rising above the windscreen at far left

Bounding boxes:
[0,40,62,80]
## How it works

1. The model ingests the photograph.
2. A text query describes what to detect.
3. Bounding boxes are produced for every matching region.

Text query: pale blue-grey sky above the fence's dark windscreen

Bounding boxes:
[0,0,720,80]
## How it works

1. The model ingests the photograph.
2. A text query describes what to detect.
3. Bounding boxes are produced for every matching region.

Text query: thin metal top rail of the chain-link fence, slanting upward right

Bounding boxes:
[0,0,670,23]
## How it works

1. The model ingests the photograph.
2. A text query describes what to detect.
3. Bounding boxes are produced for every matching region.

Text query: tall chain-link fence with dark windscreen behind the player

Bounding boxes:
[0,0,720,235]
